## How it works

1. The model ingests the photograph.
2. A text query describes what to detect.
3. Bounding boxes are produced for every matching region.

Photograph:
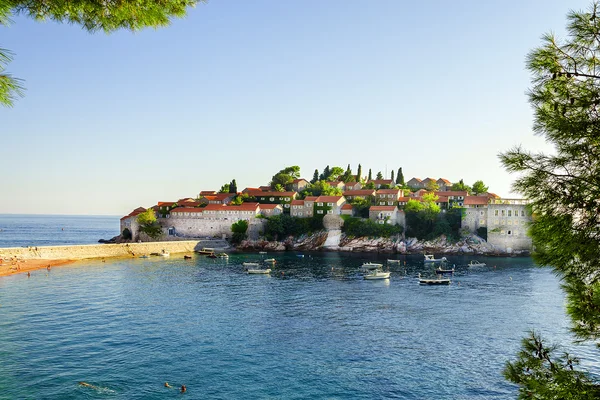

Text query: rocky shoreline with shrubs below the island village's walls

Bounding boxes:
[238,232,529,256]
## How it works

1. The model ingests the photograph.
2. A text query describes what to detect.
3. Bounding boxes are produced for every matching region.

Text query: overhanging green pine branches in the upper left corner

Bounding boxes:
[0,0,198,106]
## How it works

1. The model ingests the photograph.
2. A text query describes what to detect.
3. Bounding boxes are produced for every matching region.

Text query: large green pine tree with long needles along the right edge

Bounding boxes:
[500,1,600,399]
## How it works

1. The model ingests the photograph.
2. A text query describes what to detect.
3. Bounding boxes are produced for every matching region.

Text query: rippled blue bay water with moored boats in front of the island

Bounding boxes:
[0,253,600,399]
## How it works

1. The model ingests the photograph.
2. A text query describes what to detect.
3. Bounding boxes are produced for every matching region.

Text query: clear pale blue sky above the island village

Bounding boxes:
[0,0,590,215]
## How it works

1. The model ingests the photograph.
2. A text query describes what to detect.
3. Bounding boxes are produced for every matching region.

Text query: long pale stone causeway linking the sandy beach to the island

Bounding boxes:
[0,240,229,260]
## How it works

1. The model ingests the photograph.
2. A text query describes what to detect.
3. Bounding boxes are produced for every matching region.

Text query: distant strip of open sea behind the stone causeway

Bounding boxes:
[0,214,120,247]
